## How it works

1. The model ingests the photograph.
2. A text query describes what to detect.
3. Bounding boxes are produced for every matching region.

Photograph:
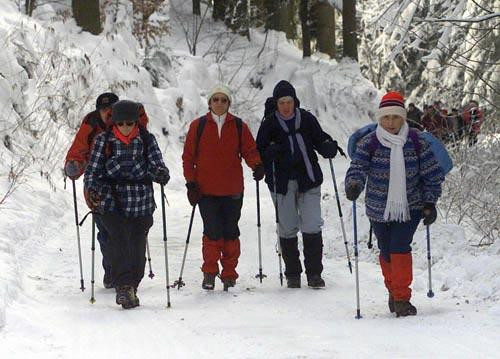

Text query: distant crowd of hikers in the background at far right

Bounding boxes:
[408,100,484,146]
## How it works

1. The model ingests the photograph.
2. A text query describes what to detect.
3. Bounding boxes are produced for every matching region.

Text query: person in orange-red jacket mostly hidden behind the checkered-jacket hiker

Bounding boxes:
[64,92,148,288]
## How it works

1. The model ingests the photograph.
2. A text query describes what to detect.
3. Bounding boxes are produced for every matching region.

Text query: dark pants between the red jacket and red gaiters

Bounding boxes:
[198,194,243,240]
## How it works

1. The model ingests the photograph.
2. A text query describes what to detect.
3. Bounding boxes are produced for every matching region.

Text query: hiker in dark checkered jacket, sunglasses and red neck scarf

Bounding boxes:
[84,100,170,309]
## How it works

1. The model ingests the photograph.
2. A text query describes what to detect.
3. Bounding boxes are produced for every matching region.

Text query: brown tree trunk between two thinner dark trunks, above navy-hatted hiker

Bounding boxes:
[311,1,335,58]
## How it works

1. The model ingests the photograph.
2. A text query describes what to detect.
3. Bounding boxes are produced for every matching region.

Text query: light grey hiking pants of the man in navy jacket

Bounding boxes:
[271,180,323,238]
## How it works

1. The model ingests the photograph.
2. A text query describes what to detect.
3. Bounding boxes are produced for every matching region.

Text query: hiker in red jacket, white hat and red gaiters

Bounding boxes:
[182,85,264,290]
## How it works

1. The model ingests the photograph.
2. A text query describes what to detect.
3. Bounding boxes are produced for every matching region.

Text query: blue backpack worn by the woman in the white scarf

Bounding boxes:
[347,123,453,175]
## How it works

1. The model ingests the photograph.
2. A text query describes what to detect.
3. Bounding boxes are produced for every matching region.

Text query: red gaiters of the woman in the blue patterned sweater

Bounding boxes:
[379,252,413,301]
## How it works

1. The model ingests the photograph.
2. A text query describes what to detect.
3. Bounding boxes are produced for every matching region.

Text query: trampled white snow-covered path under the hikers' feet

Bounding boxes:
[0,163,500,359]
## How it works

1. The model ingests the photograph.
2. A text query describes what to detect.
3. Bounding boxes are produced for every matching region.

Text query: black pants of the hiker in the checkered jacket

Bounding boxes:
[99,213,153,287]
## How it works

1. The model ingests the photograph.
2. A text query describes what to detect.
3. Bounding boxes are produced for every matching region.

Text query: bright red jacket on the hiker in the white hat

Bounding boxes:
[182,112,262,196]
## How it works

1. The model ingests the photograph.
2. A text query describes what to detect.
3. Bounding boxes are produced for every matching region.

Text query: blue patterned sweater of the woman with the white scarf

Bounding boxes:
[345,130,444,222]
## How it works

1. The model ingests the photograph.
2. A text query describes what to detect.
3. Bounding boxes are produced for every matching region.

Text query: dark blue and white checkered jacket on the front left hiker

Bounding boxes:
[84,132,165,217]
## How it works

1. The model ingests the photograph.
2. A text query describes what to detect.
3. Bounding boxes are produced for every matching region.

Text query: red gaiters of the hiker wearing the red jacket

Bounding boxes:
[201,236,240,280]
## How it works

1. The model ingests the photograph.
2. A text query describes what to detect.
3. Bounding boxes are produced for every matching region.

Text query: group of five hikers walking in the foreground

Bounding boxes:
[65,81,444,316]
